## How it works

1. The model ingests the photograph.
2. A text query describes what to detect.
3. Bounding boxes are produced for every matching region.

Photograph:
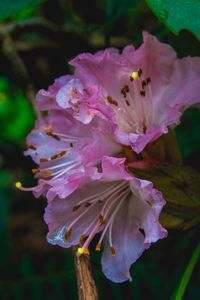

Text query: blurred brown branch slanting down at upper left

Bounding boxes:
[1,32,41,118]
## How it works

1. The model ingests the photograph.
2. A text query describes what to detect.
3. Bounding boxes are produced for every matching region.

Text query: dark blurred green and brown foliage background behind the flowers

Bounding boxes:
[0,0,200,300]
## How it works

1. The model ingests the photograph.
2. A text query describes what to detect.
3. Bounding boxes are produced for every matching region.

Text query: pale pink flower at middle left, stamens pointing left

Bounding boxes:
[20,108,121,201]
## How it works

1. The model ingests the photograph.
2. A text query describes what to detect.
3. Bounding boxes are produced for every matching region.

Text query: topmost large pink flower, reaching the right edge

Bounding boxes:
[69,32,200,153]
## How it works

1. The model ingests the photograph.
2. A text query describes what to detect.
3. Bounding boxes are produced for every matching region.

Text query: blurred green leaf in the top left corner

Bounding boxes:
[0,0,46,20]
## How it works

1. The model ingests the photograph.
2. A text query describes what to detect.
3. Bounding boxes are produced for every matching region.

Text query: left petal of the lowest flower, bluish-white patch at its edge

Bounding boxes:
[44,181,114,247]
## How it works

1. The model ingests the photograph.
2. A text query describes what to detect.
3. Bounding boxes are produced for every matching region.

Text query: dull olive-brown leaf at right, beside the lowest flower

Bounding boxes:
[132,164,200,230]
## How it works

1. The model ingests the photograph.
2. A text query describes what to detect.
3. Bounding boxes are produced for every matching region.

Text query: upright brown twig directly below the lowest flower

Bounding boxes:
[73,247,98,300]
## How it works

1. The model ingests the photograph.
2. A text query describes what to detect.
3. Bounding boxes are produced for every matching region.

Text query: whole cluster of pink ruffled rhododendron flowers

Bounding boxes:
[17,33,200,282]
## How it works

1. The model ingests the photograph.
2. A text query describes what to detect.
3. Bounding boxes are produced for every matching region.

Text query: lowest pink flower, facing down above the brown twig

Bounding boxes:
[45,156,167,282]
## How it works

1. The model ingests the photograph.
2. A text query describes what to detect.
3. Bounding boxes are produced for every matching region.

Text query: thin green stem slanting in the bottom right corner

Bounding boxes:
[172,244,200,300]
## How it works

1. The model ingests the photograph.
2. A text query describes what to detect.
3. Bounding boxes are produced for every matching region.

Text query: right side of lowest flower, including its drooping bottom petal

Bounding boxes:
[102,179,166,282]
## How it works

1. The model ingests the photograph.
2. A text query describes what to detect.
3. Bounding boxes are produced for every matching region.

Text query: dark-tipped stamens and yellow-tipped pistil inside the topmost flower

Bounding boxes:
[107,69,152,134]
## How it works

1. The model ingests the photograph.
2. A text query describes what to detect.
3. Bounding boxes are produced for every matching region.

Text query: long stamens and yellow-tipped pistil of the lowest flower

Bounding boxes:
[65,181,130,255]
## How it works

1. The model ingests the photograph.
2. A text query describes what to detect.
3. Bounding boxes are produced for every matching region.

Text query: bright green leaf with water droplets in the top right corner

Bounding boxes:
[146,0,200,39]
